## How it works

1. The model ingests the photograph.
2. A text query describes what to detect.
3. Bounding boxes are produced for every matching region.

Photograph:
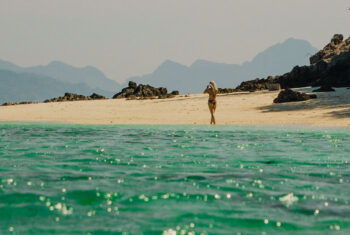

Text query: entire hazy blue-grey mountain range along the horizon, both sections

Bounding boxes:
[0,38,317,103]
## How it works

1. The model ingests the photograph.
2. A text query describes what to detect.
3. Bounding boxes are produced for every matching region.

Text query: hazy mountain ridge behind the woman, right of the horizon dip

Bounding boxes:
[127,38,318,93]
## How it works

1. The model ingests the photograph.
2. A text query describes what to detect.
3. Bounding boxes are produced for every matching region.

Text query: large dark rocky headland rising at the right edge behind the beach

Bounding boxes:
[237,34,350,91]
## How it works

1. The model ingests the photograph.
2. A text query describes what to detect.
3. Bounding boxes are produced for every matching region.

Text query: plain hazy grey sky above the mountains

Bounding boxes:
[0,0,350,82]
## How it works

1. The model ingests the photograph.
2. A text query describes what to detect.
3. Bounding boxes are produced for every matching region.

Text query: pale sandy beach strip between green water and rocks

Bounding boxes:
[0,88,350,127]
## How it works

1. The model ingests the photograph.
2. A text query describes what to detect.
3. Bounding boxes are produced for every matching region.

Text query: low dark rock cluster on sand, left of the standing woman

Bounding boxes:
[113,81,179,99]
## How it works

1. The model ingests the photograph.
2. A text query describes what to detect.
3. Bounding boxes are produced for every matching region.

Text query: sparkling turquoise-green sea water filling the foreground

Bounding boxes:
[0,123,350,234]
